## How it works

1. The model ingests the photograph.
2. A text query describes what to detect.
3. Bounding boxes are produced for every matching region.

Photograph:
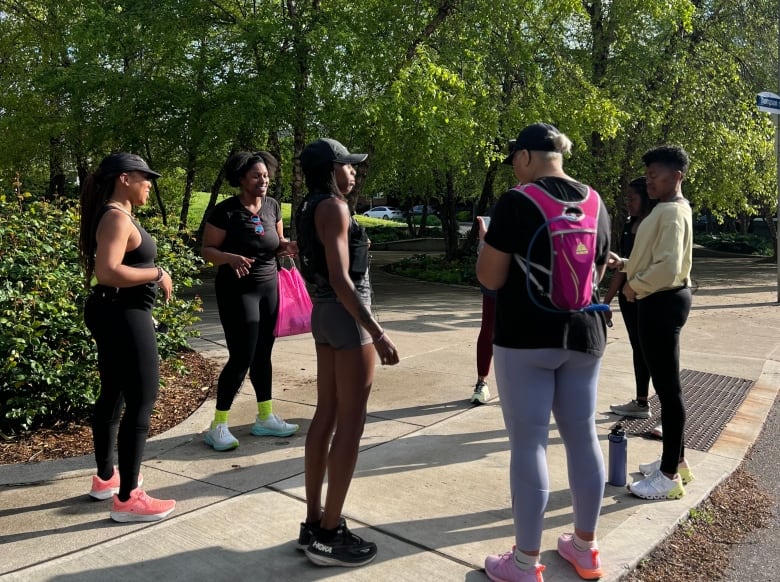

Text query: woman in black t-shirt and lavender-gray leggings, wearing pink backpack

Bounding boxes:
[477,123,610,580]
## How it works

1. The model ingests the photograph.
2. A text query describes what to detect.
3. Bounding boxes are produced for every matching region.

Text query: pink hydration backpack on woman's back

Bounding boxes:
[514,184,608,313]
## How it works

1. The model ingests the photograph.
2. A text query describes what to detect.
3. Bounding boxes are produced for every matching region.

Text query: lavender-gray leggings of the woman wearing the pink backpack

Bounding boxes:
[494,346,605,551]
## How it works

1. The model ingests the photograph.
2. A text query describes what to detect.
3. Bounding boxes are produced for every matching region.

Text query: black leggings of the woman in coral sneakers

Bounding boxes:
[84,295,160,500]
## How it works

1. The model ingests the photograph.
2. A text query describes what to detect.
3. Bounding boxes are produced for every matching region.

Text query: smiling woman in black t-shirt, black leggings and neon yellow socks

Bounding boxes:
[202,152,298,451]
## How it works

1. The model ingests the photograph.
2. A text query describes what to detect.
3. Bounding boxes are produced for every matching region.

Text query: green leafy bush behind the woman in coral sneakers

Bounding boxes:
[0,195,200,432]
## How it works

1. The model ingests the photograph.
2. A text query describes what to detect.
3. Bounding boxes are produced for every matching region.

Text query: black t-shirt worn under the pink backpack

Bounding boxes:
[485,177,610,356]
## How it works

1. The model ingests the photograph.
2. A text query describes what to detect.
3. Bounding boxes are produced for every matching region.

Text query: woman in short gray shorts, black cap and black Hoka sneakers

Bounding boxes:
[295,139,398,566]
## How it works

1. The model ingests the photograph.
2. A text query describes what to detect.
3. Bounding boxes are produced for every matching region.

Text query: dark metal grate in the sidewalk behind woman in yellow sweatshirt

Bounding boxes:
[621,370,753,452]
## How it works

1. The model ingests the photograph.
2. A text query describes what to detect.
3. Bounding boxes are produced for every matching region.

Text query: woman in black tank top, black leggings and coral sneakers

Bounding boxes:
[79,153,176,522]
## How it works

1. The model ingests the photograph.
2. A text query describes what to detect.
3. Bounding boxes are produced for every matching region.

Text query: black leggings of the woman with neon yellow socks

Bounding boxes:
[215,273,279,410]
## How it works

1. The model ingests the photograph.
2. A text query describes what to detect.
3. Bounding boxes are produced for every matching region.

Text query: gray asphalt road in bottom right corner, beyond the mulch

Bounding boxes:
[723,398,780,582]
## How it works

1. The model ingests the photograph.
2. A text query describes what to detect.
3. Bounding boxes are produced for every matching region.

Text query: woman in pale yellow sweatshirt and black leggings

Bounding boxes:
[610,146,693,499]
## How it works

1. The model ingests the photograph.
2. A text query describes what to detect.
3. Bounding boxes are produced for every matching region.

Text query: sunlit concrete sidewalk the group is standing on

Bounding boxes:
[0,252,780,582]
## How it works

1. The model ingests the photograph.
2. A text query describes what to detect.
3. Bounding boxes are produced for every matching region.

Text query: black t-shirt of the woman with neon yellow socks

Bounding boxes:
[208,196,282,281]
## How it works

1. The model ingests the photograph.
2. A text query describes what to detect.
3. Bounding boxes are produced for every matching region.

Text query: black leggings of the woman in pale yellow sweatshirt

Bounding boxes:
[637,287,691,474]
